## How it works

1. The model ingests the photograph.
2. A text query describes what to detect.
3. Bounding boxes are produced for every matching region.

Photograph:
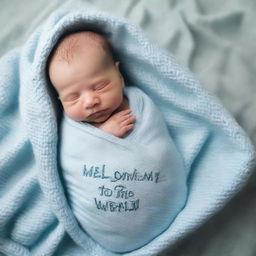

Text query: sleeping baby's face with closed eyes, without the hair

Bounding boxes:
[49,46,124,123]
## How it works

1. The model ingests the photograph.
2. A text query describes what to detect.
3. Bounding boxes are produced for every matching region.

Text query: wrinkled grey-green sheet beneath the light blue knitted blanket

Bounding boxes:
[0,0,256,256]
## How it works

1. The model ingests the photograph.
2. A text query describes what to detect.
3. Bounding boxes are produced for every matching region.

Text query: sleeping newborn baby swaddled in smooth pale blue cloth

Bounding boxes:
[48,31,187,252]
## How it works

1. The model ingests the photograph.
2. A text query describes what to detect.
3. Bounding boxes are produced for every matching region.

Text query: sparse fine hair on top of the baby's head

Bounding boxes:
[49,31,114,63]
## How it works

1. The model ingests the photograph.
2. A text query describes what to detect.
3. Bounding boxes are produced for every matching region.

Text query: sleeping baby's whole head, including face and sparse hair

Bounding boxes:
[48,31,124,123]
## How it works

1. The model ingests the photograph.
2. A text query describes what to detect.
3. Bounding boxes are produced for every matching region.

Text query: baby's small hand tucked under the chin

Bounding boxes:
[99,109,136,138]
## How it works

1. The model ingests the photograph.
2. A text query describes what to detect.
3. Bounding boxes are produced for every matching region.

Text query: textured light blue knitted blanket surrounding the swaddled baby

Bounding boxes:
[0,7,255,256]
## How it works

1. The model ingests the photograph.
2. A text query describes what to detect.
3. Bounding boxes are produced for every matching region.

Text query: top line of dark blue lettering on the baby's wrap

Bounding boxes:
[83,164,160,183]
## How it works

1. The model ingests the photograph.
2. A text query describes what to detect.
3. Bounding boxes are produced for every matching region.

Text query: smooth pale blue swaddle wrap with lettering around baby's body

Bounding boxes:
[60,86,187,252]
